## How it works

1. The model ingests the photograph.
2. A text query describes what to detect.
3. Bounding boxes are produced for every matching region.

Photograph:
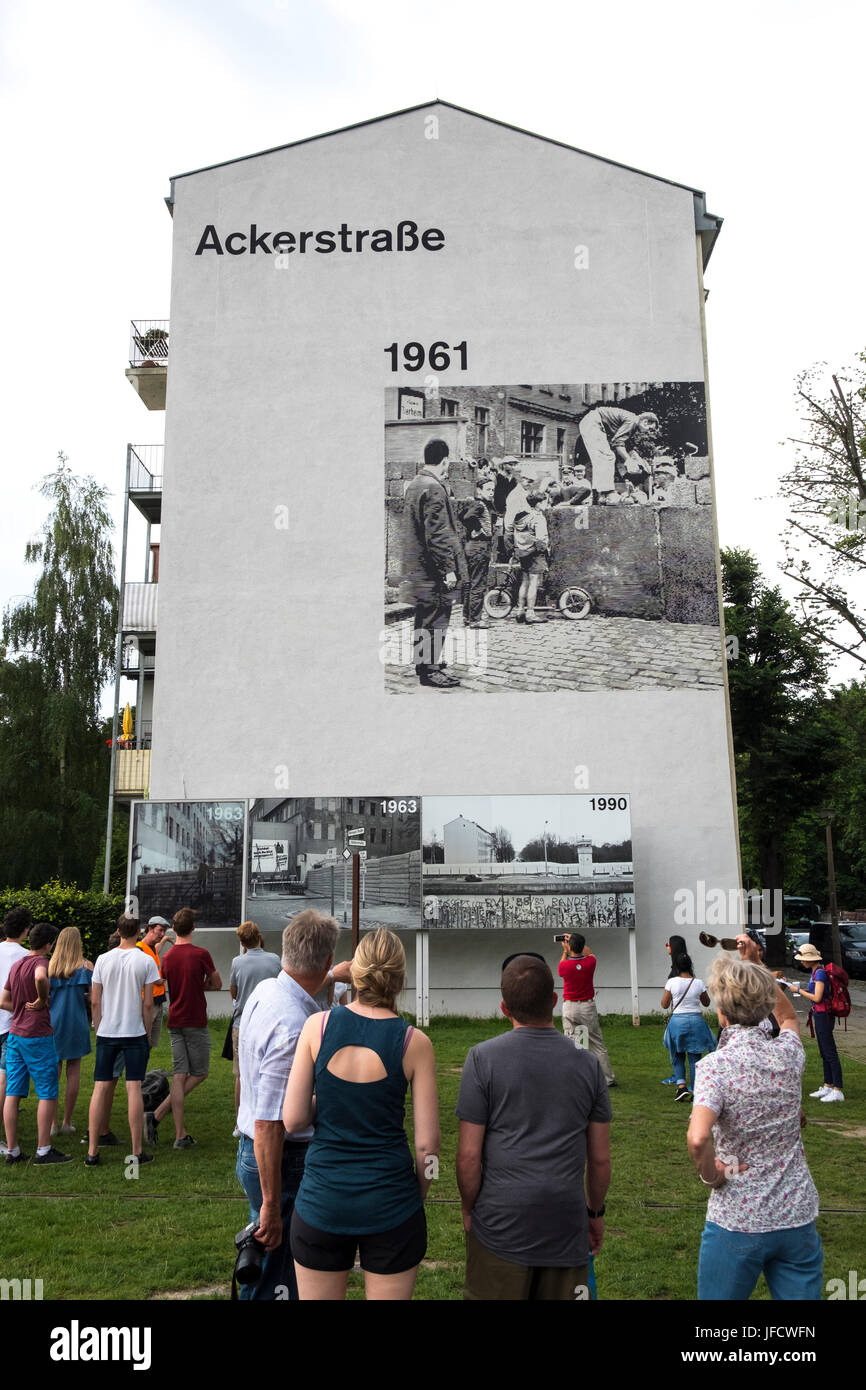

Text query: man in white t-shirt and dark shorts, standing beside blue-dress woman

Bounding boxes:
[85,917,160,1168]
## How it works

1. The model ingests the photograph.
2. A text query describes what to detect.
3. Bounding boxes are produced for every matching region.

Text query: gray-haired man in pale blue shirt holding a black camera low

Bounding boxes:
[236,908,350,1300]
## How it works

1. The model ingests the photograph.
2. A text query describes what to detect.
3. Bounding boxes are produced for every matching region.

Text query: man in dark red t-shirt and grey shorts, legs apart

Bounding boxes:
[145,908,222,1148]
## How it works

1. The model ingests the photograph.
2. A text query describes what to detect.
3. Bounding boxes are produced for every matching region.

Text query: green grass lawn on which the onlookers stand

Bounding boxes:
[0,1016,866,1300]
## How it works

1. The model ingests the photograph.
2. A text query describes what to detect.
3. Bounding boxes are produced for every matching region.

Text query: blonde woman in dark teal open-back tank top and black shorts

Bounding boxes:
[282,930,439,1300]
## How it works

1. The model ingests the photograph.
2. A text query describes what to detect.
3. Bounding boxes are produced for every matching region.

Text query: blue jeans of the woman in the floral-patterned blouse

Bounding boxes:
[698,1220,824,1301]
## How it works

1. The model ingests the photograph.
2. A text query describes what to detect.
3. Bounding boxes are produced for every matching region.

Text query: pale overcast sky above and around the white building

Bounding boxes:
[0,0,866,695]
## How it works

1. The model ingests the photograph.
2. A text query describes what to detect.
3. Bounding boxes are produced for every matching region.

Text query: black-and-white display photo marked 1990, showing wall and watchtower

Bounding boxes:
[423,794,634,933]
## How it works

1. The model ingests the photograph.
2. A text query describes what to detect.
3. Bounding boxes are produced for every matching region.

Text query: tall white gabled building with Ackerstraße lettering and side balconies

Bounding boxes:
[113,101,740,1013]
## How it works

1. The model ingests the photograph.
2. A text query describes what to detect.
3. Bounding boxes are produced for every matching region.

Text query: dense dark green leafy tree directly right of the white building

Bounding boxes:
[721,549,838,966]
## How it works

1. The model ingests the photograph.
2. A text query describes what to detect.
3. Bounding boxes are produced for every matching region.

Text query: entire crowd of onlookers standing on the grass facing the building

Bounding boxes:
[0,909,841,1301]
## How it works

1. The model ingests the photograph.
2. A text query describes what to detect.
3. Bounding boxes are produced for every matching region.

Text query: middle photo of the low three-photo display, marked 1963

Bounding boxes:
[246,796,421,931]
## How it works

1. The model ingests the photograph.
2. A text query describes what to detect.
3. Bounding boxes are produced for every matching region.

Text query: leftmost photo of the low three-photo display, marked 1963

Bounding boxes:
[129,801,246,930]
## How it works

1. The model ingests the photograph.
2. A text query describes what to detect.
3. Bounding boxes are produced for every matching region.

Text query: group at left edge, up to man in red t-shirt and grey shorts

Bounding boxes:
[0,908,222,1168]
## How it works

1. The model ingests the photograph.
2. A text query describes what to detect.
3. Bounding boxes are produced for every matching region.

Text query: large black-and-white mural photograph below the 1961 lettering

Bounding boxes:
[382,377,723,694]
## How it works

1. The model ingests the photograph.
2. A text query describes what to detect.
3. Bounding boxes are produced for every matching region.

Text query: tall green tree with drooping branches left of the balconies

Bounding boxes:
[0,453,118,884]
